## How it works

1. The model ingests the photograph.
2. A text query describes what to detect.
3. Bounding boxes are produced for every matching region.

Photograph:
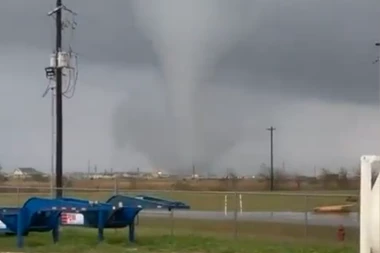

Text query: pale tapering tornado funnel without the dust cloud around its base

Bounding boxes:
[123,0,262,169]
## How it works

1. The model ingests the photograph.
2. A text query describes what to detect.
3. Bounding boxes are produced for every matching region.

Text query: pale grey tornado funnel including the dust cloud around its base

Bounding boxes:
[111,0,266,170]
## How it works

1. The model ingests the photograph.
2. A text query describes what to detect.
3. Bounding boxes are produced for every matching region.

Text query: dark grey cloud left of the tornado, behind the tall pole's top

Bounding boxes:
[0,0,156,64]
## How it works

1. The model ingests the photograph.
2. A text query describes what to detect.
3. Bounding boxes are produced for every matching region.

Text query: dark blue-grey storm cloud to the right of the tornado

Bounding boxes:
[214,0,380,103]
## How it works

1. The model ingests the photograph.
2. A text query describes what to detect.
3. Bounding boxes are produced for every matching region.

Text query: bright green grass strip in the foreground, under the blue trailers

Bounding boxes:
[0,227,357,253]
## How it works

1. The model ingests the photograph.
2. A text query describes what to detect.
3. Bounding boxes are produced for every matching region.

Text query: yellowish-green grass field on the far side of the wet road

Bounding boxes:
[0,190,357,212]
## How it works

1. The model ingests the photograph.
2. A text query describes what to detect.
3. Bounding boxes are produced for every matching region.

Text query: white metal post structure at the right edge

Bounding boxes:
[360,155,380,253]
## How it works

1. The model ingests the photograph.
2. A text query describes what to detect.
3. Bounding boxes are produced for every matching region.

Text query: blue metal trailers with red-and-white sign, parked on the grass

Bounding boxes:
[0,197,142,248]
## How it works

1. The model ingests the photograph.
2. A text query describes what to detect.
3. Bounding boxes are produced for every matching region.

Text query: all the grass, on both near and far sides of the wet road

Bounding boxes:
[0,191,359,253]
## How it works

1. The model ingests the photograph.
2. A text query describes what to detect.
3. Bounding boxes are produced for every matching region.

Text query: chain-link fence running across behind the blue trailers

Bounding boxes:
[0,184,359,242]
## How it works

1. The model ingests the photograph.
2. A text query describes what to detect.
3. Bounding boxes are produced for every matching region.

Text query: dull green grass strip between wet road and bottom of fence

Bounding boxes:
[137,217,359,244]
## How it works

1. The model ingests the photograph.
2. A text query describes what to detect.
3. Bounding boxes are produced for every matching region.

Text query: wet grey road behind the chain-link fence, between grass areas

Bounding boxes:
[140,210,359,227]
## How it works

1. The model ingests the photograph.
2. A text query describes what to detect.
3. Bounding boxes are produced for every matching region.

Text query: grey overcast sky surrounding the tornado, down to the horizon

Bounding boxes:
[0,0,380,173]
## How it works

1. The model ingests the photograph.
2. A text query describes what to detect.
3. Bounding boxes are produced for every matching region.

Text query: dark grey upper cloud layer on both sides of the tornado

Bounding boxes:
[0,0,380,103]
